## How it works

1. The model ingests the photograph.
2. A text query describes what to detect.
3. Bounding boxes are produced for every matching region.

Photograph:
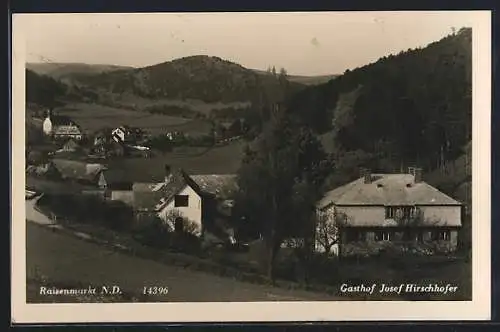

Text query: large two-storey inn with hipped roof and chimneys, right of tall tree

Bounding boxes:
[315,168,462,255]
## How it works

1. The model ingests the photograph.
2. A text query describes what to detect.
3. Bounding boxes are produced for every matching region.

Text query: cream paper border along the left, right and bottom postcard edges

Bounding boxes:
[11,11,491,323]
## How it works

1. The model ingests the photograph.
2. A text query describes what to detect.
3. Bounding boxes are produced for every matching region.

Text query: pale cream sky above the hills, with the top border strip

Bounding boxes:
[13,11,477,75]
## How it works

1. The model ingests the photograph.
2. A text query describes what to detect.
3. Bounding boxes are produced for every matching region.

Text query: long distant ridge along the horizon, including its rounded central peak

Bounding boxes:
[26,55,335,103]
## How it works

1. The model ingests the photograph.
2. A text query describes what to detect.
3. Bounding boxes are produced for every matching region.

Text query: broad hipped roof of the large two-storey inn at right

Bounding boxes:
[317,174,460,209]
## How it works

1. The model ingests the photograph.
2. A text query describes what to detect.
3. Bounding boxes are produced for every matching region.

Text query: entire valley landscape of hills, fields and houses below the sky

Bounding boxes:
[20,18,473,302]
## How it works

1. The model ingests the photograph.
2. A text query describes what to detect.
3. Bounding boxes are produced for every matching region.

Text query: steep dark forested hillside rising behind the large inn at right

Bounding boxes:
[289,28,472,179]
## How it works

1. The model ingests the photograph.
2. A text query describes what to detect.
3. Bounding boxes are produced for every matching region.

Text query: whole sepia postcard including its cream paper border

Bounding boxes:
[12,11,491,322]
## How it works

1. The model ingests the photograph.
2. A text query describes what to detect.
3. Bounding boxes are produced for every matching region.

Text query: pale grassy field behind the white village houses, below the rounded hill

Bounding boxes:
[55,103,191,135]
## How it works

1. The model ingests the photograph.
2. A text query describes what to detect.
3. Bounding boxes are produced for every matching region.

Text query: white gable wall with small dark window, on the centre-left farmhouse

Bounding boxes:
[158,186,202,236]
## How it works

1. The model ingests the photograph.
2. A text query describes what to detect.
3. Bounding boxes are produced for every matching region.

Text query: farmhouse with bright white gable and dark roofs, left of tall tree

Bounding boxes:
[133,166,235,238]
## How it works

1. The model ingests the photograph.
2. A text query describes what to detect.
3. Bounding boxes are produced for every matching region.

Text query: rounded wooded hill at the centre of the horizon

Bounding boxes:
[68,55,304,102]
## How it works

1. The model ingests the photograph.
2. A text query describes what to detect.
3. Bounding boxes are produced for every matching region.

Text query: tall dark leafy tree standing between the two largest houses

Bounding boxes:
[236,108,323,278]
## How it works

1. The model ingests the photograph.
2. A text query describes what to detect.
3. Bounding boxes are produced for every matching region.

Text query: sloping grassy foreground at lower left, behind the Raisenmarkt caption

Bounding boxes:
[26,222,335,303]
